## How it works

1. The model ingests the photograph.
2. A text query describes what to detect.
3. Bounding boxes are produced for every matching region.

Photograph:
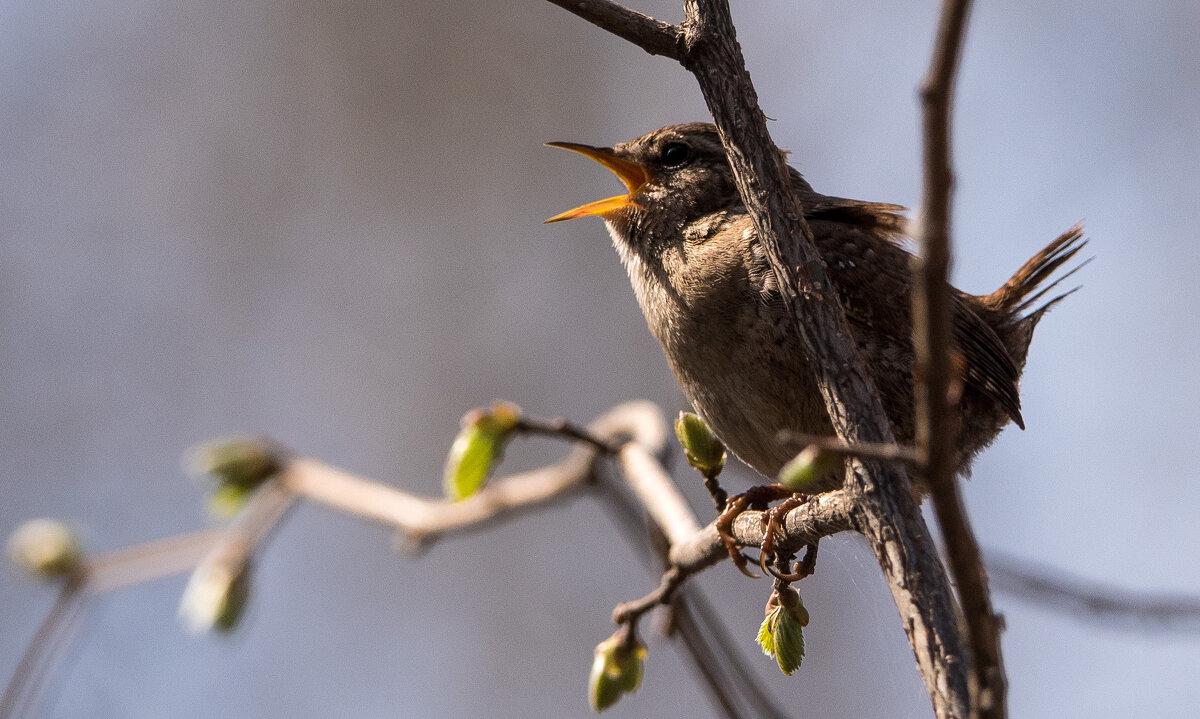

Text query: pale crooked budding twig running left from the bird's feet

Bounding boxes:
[7,402,851,719]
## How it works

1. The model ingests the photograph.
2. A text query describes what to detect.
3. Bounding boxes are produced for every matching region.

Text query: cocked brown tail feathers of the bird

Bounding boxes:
[979,223,1091,366]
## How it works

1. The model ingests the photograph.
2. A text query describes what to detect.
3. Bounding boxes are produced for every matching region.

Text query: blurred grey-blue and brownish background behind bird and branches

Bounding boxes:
[0,0,1200,718]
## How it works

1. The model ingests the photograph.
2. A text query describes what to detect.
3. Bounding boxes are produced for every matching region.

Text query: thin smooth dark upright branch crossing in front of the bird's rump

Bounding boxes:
[912,0,1007,719]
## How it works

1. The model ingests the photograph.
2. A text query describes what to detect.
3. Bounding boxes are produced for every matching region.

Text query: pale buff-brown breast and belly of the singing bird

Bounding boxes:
[617,215,830,475]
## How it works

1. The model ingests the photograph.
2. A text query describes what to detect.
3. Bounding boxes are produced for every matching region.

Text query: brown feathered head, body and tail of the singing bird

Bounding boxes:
[566,122,1085,484]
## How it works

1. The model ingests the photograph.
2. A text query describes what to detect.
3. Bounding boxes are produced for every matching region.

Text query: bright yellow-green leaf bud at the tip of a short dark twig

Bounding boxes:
[442,402,521,502]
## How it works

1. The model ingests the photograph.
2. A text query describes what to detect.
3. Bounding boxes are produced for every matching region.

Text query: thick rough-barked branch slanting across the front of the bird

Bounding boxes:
[683,0,968,718]
